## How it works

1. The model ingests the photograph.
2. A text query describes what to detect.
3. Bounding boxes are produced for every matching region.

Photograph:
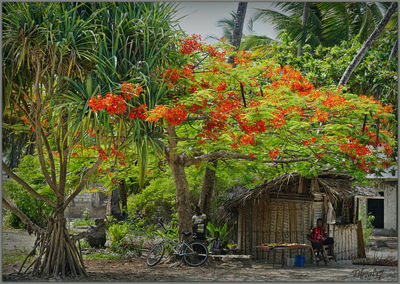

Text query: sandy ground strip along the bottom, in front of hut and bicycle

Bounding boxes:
[2,231,398,282]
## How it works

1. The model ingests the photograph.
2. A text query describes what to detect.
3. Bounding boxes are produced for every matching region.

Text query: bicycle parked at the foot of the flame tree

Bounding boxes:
[146,222,208,266]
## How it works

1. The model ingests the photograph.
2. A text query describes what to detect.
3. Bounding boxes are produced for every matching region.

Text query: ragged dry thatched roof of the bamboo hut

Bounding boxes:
[223,172,377,210]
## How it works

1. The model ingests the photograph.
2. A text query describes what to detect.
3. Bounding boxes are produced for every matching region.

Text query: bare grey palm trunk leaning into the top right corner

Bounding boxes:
[338,2,397,88]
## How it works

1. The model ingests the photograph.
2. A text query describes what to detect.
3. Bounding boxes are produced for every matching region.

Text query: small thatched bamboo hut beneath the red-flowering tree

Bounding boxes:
[224,173,376,262]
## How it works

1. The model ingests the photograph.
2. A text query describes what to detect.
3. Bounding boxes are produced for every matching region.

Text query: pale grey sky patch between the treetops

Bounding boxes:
[178,2,278,42]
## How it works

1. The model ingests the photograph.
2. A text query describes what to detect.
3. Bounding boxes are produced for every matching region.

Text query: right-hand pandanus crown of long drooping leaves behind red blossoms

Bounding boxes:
[88,3,180,192]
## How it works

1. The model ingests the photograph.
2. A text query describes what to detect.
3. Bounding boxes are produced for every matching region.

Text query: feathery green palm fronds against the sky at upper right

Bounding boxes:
[255,2,388,48]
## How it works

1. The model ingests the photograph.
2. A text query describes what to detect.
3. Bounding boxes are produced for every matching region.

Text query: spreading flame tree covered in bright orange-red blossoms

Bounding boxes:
[89,35,395,235]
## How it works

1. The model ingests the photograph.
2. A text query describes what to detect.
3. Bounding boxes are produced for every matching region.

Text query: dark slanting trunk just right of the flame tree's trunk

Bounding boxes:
[198,160,218,220]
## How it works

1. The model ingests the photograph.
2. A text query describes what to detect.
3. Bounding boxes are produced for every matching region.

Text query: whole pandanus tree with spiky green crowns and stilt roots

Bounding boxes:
[2,3,180,277]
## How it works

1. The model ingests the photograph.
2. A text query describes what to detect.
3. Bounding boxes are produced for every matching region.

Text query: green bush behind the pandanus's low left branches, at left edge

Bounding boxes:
[3,155,55,228]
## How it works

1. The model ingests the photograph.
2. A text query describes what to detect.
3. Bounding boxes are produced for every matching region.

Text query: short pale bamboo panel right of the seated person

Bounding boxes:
[328,224,358,260]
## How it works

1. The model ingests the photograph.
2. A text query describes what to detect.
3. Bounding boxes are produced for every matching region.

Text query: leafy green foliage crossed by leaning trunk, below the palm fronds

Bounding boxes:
[253,31,398,106]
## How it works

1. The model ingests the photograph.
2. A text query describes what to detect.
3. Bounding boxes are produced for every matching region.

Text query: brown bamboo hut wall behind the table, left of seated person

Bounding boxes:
[238,195,313,262]
